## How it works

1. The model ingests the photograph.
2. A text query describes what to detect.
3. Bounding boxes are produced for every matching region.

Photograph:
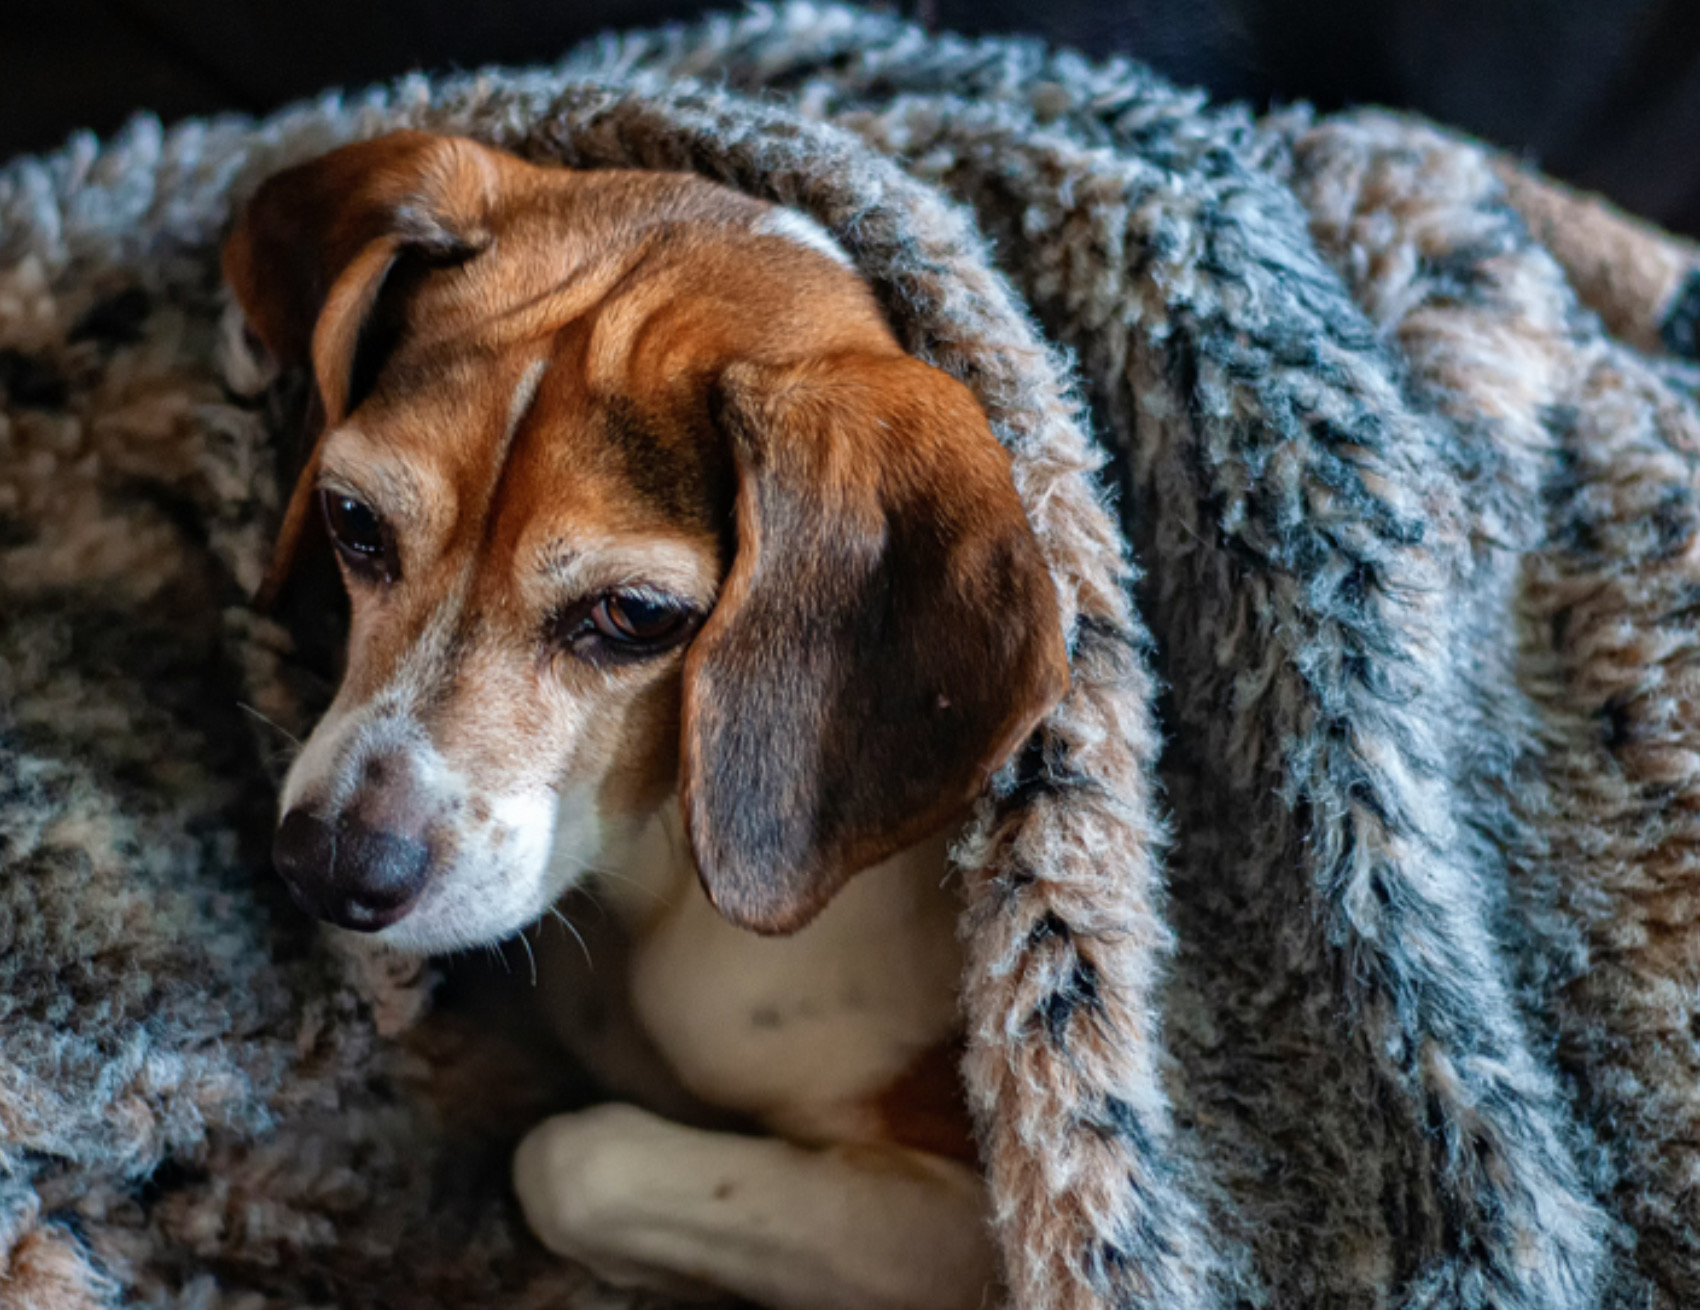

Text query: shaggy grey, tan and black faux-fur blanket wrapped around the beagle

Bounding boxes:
[0,3,1700,1310]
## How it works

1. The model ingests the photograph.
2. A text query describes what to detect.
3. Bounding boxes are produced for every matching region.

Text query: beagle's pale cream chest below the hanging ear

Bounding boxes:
[631,841,961,1140]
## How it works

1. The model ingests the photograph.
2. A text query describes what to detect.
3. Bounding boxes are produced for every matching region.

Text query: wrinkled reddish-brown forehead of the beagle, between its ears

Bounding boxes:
[341,173,886,532]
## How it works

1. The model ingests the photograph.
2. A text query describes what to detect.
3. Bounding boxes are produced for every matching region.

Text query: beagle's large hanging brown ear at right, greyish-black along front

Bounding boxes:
[680,355,1068,933]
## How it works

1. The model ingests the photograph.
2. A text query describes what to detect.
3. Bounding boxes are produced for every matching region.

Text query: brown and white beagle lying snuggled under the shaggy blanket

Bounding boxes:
[224,133,1068,1310]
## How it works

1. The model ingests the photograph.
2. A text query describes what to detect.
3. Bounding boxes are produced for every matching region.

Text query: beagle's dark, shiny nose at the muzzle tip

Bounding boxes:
[272,810,430,933]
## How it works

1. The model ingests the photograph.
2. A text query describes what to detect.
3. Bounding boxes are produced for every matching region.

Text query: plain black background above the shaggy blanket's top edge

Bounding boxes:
[0,0,1700,234]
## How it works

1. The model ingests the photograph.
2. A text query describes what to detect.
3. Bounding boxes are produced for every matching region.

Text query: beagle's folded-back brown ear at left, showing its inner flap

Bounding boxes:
[224,133,496,607]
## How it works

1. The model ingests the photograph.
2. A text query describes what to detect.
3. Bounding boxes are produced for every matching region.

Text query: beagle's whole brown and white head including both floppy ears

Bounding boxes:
[224,133,1068,950]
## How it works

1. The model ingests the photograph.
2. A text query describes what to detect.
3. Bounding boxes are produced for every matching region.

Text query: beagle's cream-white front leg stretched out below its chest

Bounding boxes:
[513,1106,995,1310]
